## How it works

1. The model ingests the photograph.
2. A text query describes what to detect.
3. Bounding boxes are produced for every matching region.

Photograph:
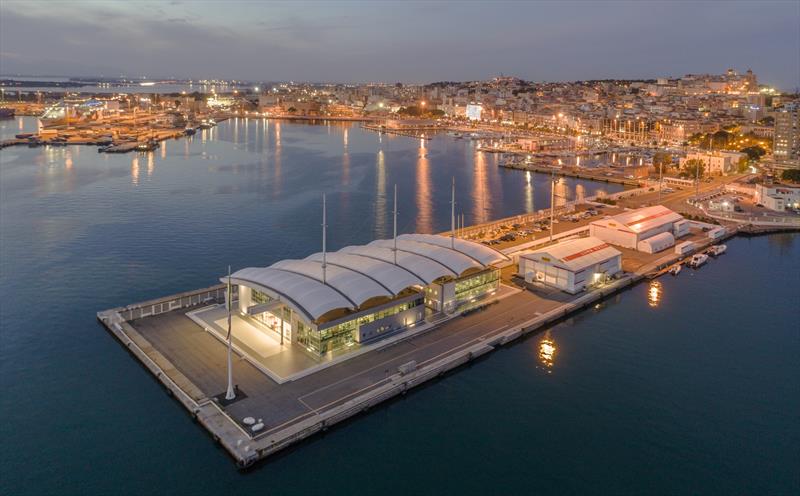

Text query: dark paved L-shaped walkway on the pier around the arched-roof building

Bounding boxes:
[131,292,575,431]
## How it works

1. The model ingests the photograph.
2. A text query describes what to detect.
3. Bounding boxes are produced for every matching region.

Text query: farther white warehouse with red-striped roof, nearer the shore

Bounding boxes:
[589,205,689,250]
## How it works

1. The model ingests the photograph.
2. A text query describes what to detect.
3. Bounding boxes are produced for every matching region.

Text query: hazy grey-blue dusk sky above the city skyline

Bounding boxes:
[0,0,800,90]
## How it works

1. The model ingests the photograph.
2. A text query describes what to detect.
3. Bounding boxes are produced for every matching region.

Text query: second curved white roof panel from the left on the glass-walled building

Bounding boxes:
[270,260,394,307]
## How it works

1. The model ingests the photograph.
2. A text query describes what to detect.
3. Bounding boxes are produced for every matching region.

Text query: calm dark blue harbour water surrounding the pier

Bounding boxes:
[0,119,800,495]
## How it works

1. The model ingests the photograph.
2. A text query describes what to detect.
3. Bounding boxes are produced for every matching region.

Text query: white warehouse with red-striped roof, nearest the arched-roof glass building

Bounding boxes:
[518,237,622,294]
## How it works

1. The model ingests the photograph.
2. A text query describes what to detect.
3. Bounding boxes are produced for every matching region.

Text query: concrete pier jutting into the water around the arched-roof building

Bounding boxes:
[92,195,780,469]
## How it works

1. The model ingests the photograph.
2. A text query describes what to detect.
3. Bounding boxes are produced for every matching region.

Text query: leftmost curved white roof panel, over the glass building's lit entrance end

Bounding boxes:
[230,267,353,320]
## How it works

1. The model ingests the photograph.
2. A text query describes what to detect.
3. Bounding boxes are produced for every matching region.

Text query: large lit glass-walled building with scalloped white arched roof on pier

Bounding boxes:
[221,234,508,356]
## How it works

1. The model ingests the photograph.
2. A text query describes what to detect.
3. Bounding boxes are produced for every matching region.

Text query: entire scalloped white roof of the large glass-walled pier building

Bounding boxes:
[228,234,508,320]
